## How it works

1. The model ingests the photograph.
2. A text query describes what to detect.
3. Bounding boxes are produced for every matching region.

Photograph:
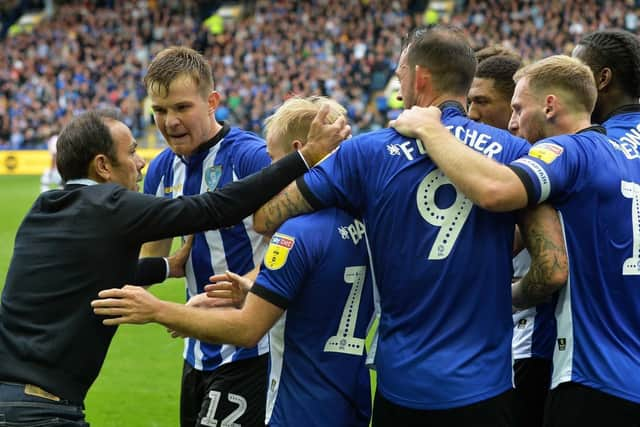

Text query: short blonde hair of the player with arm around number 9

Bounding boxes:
[513,55,598,114]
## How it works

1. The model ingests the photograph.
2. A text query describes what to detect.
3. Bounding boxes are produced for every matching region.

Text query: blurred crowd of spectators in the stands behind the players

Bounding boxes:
[0,0,640,148]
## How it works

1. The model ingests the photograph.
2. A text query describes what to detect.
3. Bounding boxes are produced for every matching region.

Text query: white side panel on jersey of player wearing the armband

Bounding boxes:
[551,212,574,389]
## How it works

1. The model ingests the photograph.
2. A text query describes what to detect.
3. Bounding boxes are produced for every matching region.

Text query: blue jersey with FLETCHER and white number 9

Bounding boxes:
[299,104,528,409]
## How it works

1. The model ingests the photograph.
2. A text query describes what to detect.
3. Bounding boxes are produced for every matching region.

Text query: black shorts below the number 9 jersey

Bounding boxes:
[373,390,513,427]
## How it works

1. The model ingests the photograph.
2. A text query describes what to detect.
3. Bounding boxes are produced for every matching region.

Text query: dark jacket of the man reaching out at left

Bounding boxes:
[0,153,306,403]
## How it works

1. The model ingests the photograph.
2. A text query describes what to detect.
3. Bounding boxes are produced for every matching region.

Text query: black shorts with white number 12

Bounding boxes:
[180,354,269,427]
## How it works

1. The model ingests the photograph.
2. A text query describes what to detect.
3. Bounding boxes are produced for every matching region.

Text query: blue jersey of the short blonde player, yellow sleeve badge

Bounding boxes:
[254,208,373,427]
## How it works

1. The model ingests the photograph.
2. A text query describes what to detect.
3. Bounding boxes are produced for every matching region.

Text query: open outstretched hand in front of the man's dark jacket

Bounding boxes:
[91,285,162,326]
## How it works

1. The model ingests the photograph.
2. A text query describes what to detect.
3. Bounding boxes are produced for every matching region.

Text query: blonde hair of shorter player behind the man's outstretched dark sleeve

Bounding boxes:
[264,96,347,149]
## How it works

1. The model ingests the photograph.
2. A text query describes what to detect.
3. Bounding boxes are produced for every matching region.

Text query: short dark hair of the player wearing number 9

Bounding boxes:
[404,25,477,96]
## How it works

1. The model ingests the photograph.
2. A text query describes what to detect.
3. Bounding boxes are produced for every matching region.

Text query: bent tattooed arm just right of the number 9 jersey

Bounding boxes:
[511,204,569,309]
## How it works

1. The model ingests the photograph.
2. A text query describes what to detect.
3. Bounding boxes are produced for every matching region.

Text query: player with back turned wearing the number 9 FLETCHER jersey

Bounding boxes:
[254,27,562,426]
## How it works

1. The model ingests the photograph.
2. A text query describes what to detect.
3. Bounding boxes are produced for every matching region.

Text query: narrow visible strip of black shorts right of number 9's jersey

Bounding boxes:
[513,357,552,427]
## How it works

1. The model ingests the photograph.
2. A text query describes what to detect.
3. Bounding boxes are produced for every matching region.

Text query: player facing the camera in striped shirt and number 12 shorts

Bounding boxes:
[141,47,270,427]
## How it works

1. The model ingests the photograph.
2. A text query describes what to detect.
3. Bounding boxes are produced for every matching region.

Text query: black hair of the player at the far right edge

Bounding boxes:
[578,30,640,98]
